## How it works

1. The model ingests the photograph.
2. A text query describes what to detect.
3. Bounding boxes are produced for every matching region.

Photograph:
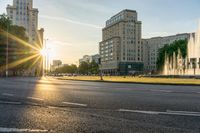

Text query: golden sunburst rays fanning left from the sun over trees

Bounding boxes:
[0,30,44,75]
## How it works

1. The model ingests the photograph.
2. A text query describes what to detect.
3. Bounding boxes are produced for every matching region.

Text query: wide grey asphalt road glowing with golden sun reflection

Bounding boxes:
[0,77,200,133]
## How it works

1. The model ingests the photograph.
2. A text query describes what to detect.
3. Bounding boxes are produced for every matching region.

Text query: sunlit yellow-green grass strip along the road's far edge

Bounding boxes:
[57,76,200,86]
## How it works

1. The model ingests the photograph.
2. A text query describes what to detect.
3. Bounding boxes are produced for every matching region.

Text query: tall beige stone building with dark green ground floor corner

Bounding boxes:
[99,10,143,75]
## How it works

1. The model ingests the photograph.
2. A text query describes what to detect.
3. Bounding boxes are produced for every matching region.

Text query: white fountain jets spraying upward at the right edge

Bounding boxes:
[163,24,200,75]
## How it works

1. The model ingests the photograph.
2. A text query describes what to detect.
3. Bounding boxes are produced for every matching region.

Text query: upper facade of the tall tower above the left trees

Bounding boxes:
[7,0,38,44]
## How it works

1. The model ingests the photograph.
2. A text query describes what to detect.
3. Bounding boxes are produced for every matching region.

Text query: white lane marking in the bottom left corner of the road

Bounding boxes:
[0,127,48,133]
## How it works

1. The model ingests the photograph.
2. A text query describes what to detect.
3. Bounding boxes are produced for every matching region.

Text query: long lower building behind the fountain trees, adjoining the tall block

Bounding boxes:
[142,33,190,72]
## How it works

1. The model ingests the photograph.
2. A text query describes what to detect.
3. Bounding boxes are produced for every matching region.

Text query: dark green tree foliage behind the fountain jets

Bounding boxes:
[157,40,188,71]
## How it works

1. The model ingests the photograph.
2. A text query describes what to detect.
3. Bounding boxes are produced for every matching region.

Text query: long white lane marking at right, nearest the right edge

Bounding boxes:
[118,109,200,117]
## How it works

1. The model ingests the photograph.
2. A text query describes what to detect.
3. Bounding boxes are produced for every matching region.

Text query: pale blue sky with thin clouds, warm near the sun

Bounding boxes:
[0,0,200,64]
